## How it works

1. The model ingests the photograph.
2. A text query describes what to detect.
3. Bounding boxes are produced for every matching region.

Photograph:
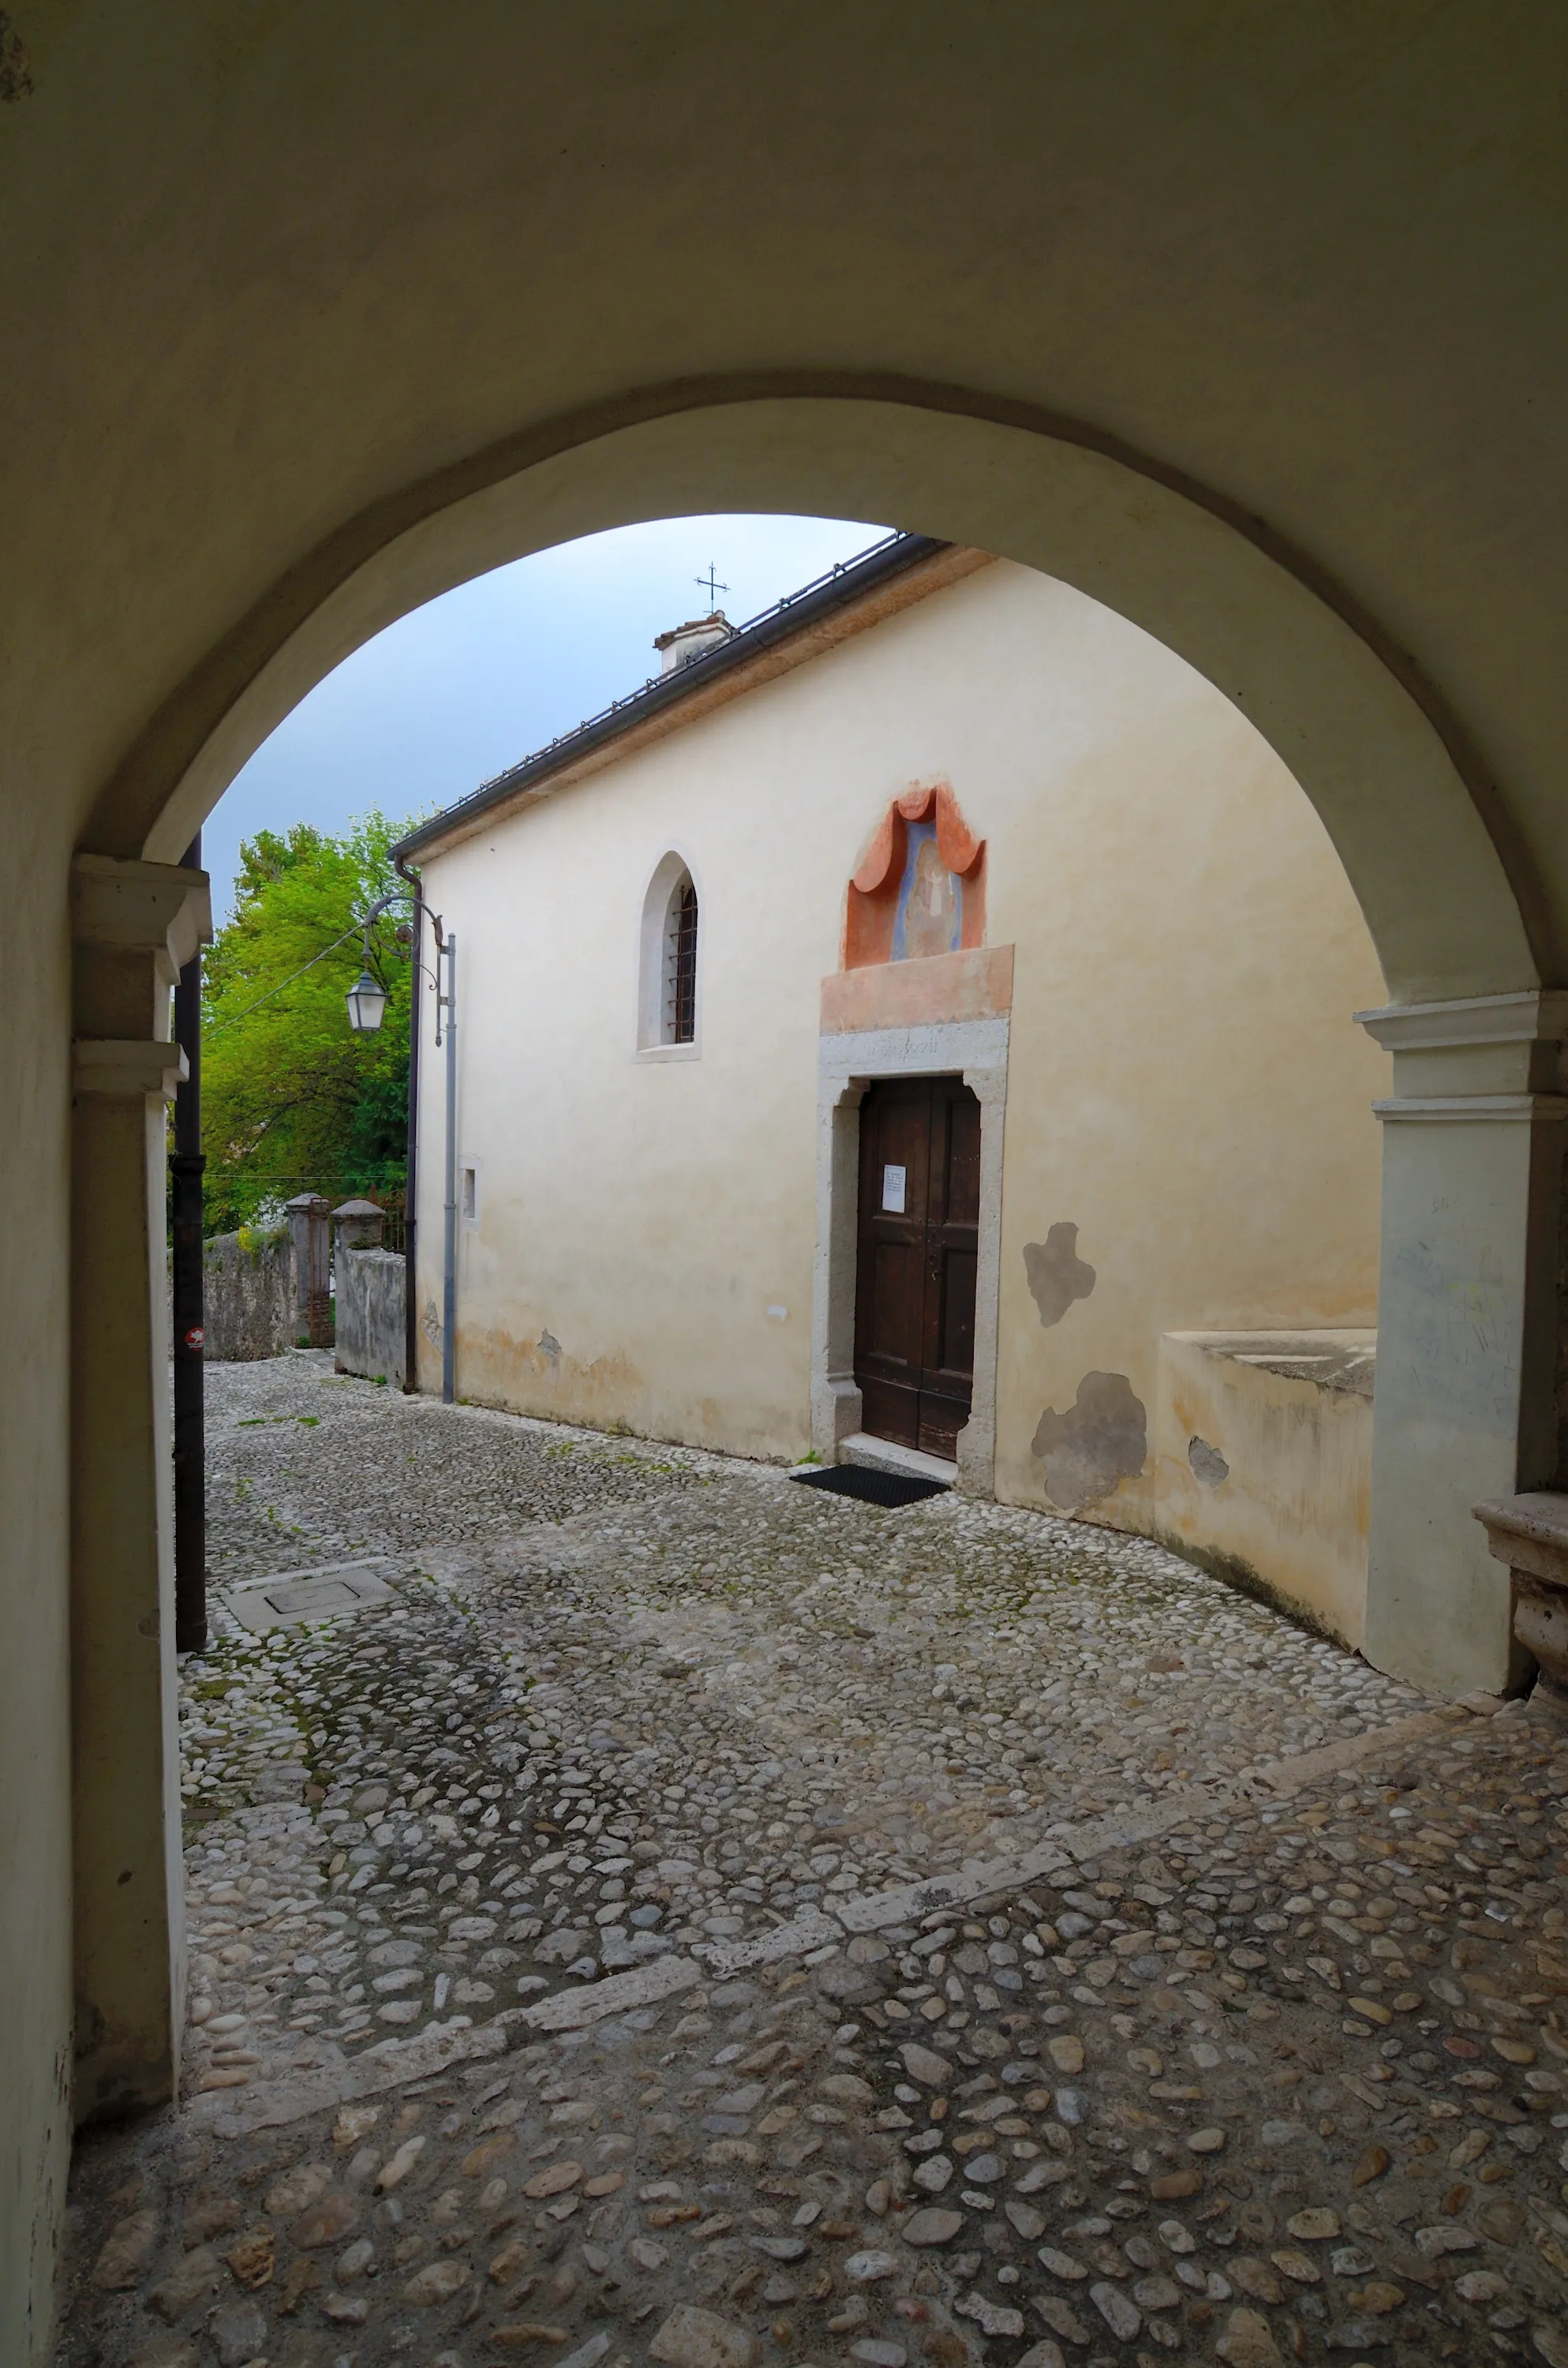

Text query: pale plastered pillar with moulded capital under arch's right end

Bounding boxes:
[1357,992,1568,1693]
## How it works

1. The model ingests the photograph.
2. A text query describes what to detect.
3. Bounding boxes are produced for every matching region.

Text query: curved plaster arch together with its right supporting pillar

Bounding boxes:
[90,381,1561,1688]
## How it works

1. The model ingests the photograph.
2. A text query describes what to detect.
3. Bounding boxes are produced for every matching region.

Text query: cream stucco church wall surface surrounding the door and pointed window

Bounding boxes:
[419,564,1386,1527]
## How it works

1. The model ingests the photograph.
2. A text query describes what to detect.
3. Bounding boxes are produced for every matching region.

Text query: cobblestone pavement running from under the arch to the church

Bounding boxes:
[59,1354,1568,2368]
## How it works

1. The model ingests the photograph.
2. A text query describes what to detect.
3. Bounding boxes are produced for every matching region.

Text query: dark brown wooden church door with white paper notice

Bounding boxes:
[855,1077,981,1461]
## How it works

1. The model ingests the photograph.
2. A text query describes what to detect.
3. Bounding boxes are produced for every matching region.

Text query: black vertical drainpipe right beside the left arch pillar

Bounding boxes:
[168,831,206,1653]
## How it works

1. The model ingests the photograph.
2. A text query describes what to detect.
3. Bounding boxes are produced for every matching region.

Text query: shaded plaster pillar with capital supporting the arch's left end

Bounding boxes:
[71,855,211,2122]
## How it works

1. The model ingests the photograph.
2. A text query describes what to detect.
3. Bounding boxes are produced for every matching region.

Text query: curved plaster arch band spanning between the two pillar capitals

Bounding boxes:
[110,386,1542,1002]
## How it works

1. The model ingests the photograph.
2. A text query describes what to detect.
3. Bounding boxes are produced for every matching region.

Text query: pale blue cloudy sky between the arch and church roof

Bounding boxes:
[201,516,886,921]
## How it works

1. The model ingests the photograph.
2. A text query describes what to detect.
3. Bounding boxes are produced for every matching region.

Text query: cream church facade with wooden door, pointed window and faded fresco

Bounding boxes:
[405,535,1388,1641]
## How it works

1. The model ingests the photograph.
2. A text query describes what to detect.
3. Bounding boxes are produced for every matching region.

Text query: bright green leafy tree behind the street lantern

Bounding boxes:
[201,812,424,1234]
